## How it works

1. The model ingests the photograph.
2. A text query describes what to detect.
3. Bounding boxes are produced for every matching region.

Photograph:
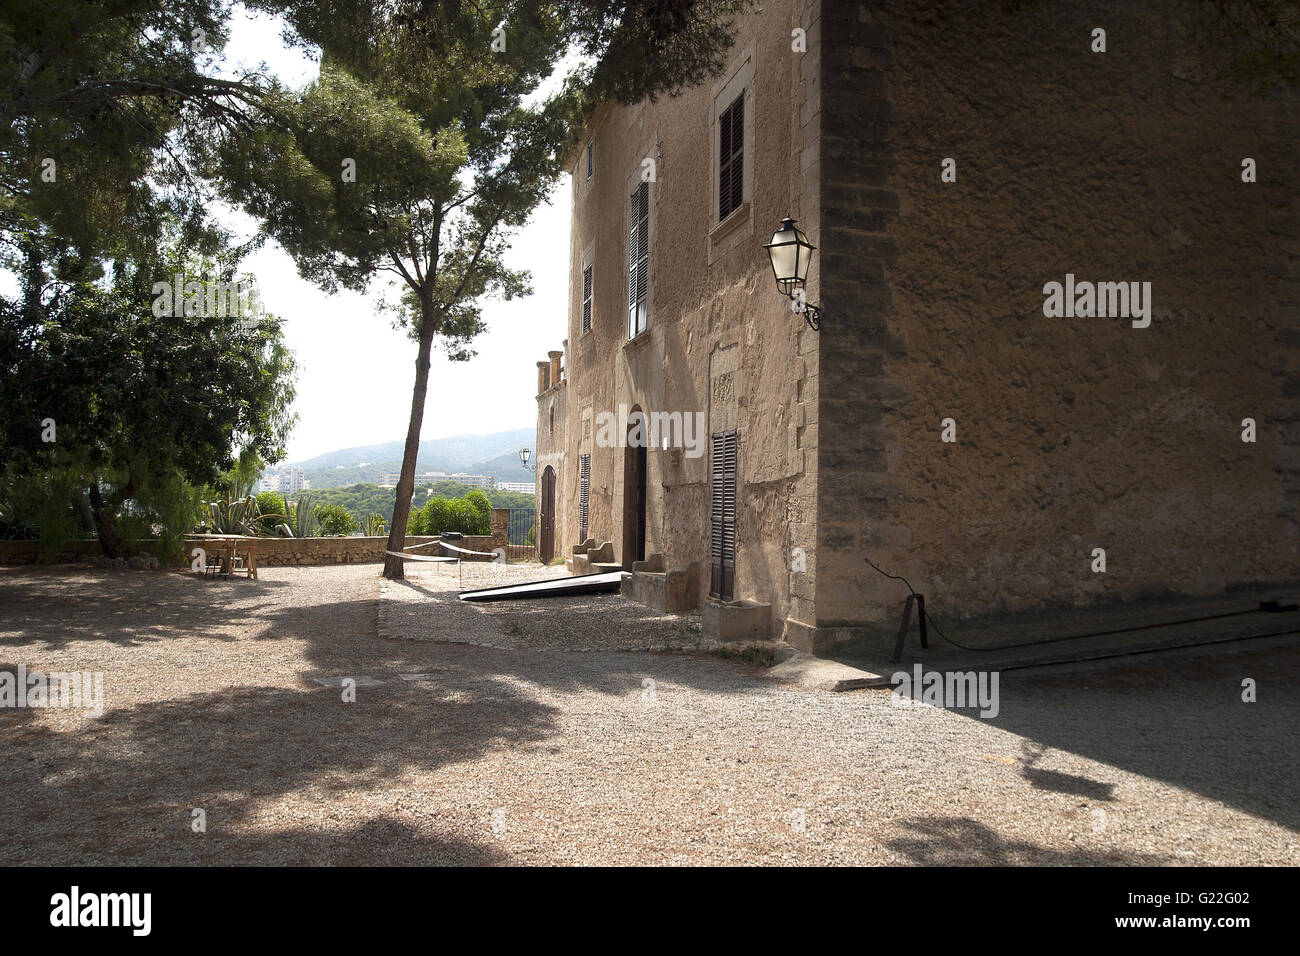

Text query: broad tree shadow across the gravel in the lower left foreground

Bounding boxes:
[0,680,555,864]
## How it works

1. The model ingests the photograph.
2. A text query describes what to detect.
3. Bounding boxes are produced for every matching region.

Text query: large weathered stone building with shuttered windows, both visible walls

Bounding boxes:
[536,0,1300,648]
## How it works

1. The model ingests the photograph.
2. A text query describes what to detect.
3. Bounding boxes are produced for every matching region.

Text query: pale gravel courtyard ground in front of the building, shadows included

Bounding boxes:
[0,564,1300,865]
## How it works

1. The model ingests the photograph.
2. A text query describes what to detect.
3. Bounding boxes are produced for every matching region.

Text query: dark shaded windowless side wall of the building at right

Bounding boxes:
[816,0,1300,627]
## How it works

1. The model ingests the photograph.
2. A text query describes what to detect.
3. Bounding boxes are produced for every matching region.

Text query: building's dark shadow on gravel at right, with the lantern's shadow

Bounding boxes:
[954,645,1300,830]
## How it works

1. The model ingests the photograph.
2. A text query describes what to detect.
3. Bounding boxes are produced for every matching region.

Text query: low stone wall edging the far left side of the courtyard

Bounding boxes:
[0,535,497,567]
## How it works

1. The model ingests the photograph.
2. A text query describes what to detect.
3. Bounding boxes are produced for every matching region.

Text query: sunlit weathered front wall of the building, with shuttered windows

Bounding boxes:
[559,0,820,636]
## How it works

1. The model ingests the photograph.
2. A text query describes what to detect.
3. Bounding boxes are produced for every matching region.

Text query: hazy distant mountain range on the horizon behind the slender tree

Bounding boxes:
[267,428,537,488]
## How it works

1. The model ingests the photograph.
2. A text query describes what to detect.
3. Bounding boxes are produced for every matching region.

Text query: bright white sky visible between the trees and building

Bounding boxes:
[224,0,569,463]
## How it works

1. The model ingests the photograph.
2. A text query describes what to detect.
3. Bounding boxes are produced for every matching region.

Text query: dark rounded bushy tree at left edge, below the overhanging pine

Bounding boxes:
[0,239,294,554]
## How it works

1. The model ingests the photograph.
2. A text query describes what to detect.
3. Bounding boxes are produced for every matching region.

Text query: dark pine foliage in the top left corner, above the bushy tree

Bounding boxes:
[0,0,258,269]
